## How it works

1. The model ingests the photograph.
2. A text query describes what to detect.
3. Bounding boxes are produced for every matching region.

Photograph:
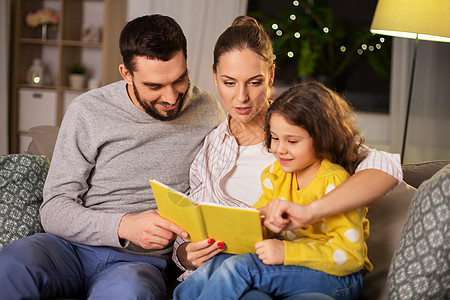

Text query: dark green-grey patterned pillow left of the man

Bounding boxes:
[0,154,49,249]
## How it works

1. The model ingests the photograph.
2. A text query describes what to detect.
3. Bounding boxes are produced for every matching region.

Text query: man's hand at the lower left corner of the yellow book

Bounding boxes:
[118,210,188,249]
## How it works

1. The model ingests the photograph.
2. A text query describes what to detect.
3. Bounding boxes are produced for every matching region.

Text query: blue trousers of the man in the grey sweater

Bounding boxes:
[0,233,167,300]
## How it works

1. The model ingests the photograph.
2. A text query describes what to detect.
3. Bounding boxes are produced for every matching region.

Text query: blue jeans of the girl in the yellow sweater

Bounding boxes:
[174,253,364,299]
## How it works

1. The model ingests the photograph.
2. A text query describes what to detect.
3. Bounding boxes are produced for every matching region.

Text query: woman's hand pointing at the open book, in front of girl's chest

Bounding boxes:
[259,199,314,233]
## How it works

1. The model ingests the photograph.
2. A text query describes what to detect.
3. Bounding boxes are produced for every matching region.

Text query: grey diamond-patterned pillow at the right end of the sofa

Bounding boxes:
[388,164,450,299]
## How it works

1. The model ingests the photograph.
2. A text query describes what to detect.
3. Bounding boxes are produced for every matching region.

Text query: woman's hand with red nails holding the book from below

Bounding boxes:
[177,239,225,270]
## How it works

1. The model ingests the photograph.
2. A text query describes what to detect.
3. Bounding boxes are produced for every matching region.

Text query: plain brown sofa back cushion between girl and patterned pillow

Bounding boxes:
[360,182,416,300]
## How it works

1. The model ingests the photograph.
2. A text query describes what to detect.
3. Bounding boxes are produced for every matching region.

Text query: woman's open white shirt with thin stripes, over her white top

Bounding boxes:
[172,116,403,281]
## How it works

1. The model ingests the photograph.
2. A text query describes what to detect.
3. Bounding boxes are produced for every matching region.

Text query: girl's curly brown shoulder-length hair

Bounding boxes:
[264,81,367,174]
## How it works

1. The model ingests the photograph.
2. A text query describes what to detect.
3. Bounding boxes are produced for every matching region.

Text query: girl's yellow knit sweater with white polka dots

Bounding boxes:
[254,160,373,276]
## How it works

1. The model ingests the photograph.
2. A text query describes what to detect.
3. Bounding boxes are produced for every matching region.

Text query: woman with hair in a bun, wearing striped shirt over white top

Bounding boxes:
[173,16,402,290]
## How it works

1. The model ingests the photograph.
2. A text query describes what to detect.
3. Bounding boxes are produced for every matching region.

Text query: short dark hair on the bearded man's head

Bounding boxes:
[119,14,187,73]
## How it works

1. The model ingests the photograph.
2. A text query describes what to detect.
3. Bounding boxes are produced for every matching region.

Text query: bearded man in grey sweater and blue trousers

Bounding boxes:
[0,15,224,299]
